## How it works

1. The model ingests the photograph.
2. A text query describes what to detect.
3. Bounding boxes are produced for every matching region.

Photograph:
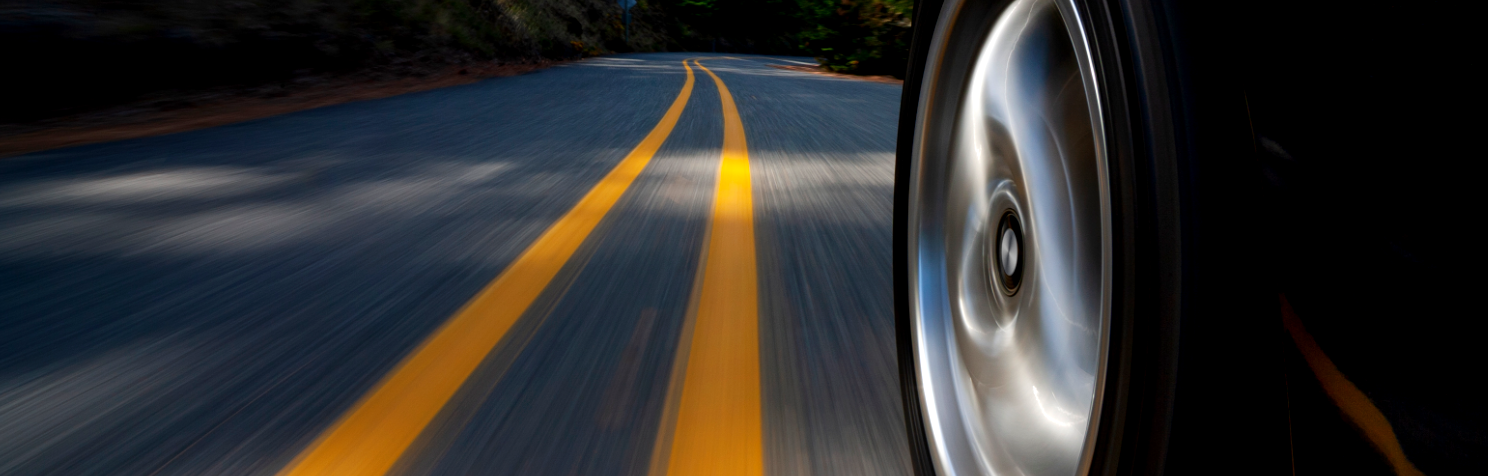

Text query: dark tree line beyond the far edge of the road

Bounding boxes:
[0,0,912,122]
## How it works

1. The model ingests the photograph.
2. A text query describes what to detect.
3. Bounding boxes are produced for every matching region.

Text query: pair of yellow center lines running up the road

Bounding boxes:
[278,60,763,476]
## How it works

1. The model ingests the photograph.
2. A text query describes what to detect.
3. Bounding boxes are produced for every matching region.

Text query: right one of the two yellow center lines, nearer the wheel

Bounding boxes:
[667,60,765,476]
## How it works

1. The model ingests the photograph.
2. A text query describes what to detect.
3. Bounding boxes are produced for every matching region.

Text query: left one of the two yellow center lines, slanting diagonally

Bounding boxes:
[280,62,693,476]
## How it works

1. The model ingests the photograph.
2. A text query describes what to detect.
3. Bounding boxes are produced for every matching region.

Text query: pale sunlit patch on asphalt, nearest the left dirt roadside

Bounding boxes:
[0,159,535,257]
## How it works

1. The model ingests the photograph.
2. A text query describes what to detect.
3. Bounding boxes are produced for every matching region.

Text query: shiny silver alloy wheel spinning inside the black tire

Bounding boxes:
[906,0,1112,475]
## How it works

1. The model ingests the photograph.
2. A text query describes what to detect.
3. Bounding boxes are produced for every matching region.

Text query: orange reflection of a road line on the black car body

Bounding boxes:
[1281,296,1423,476]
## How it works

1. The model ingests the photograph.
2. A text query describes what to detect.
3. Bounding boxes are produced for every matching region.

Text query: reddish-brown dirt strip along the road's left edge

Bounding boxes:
[0,60,567,158]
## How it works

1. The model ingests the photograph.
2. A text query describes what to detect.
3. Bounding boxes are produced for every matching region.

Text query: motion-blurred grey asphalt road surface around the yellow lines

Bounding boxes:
[0,54,909,475]
